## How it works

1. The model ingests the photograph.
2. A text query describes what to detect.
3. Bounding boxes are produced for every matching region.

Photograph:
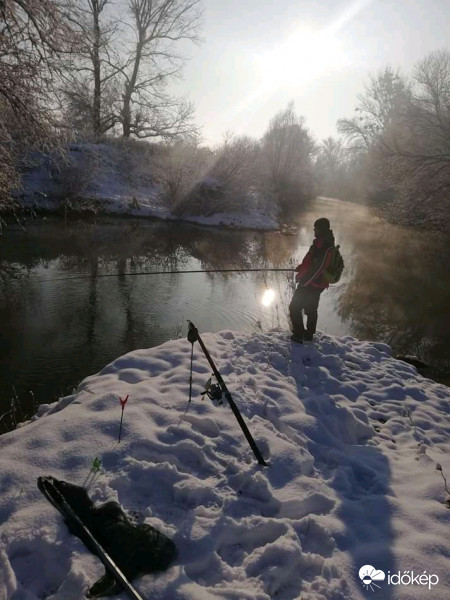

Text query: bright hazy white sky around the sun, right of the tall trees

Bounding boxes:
[171,0,450,144]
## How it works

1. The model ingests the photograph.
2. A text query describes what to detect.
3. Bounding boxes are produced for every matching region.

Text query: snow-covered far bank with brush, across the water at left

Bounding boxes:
[17,144,279,230]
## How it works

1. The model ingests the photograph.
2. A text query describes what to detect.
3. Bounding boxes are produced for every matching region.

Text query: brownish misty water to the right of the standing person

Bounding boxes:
[337,214,450,374]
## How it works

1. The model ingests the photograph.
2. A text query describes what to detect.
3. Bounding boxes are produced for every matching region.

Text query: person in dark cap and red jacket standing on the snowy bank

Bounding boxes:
[289,217,334,343]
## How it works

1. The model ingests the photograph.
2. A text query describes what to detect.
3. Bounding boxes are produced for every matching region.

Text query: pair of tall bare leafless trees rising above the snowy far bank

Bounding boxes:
[60,0,201,141]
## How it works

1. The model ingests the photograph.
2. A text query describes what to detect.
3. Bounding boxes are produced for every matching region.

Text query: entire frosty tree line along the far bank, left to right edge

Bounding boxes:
[0,0,450,230]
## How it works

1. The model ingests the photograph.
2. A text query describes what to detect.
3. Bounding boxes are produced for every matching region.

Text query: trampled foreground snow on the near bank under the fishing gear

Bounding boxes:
[0,329,450,600]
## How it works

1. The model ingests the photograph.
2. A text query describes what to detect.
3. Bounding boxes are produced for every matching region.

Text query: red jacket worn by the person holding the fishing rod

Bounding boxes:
[294,230,334,289]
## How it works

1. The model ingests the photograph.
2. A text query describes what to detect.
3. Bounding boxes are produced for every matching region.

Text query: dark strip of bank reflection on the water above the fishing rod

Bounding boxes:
[1,220,297,275]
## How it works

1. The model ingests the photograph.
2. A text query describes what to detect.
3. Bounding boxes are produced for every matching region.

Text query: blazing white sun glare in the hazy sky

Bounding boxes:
[257,29,348,88]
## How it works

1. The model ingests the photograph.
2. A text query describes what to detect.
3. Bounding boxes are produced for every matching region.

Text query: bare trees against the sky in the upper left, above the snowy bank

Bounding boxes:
[0,0,201,213]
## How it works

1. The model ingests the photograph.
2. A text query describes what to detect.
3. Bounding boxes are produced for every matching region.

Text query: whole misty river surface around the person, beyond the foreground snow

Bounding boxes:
[0,199,450,432]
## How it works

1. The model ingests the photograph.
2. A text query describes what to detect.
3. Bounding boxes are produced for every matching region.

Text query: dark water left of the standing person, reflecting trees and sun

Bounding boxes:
[0,219,296,431]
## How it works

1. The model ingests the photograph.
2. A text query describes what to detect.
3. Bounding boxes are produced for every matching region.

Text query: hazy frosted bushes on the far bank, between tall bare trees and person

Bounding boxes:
[158,102,316,221]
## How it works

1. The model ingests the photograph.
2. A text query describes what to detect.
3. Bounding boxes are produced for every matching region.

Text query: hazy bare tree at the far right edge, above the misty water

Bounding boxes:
[383,51,450,231]
